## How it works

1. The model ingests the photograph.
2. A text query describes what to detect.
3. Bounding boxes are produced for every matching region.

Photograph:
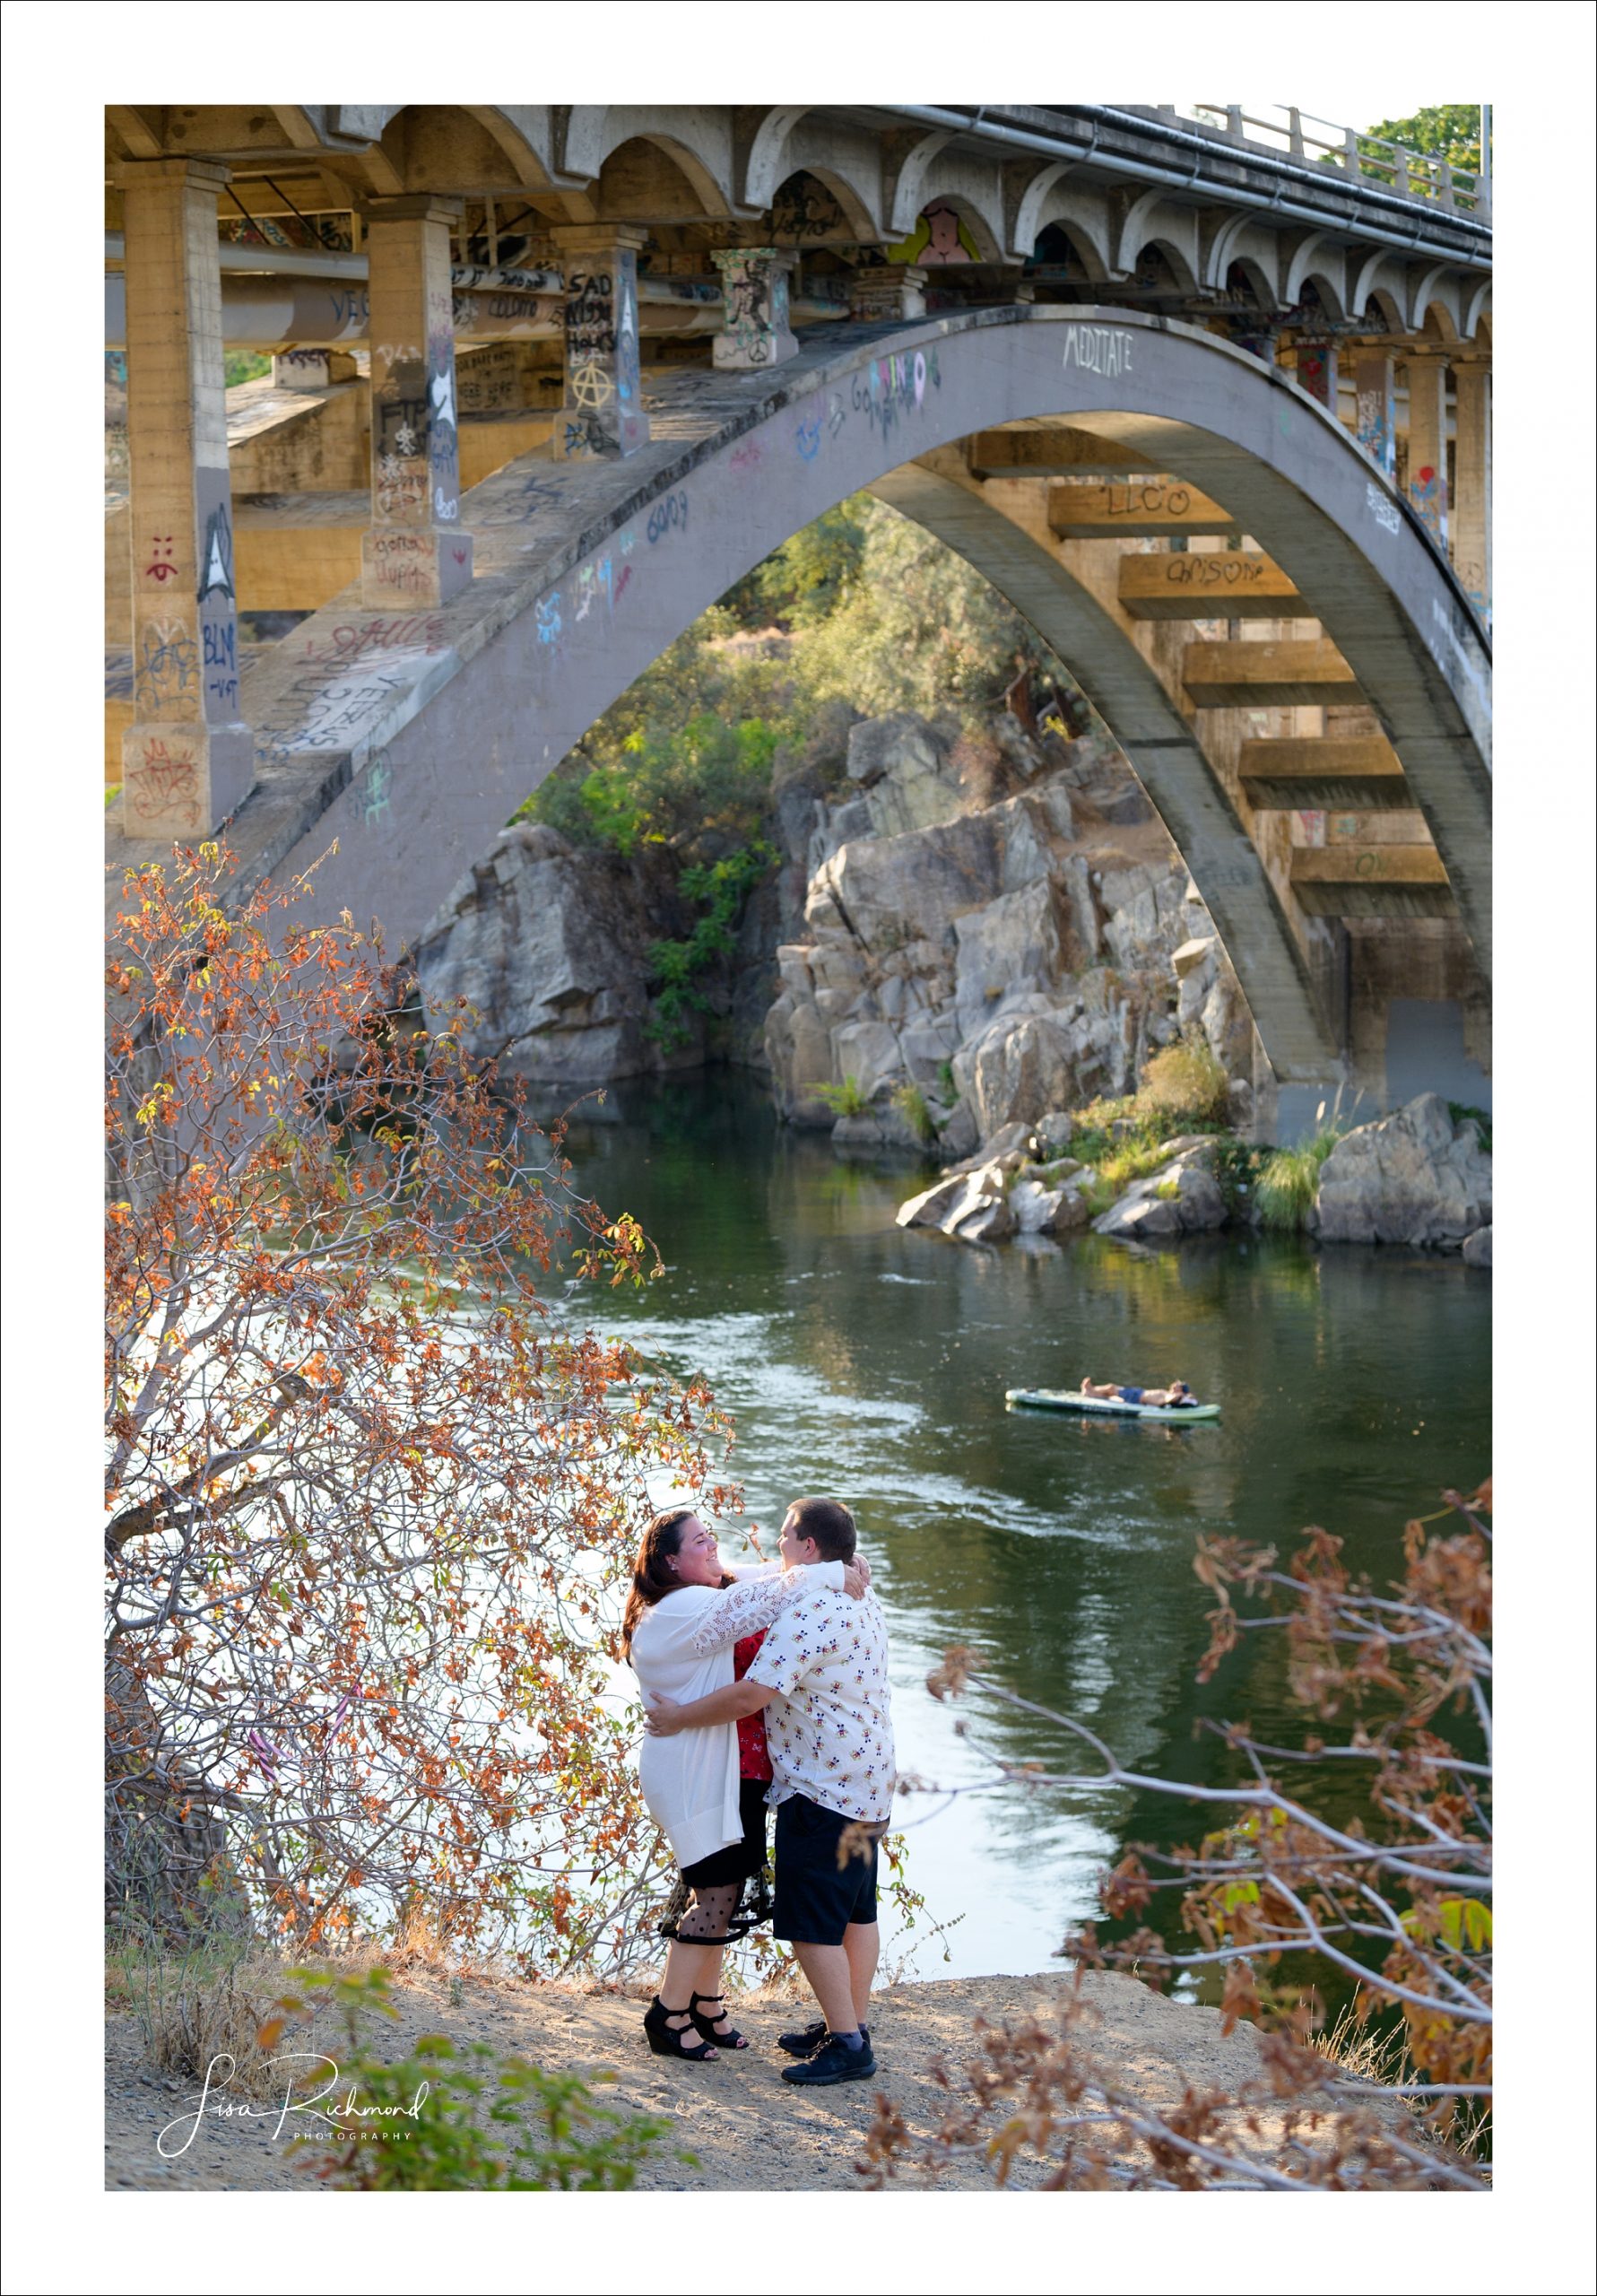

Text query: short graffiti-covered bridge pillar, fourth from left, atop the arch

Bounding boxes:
[549,222,649,462]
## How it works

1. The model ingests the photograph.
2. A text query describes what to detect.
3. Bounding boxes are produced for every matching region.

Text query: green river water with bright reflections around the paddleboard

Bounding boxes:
[555,1070,1491,1977]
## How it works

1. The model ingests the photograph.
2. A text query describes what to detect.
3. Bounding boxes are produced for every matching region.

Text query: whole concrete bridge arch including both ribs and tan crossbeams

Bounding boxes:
[112,305,1491,1123]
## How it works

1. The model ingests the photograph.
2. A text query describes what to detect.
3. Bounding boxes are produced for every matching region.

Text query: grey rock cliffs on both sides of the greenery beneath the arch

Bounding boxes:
[418,709,1253,1157]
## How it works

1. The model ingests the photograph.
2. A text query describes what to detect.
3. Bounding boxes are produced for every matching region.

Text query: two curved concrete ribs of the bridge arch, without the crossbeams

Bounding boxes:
[171,305,1489,1077]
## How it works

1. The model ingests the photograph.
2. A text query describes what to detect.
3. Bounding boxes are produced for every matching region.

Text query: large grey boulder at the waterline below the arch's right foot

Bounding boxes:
[1317,1093,1491,1251]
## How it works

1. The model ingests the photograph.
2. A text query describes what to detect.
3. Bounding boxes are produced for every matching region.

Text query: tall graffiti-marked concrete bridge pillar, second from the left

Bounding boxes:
[360,193,471,613]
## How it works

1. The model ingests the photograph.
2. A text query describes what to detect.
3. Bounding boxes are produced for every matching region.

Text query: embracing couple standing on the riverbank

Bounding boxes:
[621,1500,892,2087]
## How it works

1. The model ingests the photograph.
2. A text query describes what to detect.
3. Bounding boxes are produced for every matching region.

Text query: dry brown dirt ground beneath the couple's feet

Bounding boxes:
[106,1972,1349,2193]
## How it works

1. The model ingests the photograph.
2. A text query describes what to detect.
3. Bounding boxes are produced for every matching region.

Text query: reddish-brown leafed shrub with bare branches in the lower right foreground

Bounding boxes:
[867,1483,1491,2190]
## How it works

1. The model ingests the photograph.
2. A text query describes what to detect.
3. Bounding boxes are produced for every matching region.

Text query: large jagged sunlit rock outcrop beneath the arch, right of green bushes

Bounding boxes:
[764,712,1253,1157]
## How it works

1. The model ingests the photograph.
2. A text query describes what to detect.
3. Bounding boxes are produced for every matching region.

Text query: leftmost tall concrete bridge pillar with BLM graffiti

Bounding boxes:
[122,159,255,838]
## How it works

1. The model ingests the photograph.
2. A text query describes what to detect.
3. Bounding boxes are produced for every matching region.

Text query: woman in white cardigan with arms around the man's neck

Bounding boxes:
[621,1506,870,2057]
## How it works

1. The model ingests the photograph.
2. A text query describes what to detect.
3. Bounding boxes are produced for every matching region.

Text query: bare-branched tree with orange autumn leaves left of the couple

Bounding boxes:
[106,848,732,1965]
